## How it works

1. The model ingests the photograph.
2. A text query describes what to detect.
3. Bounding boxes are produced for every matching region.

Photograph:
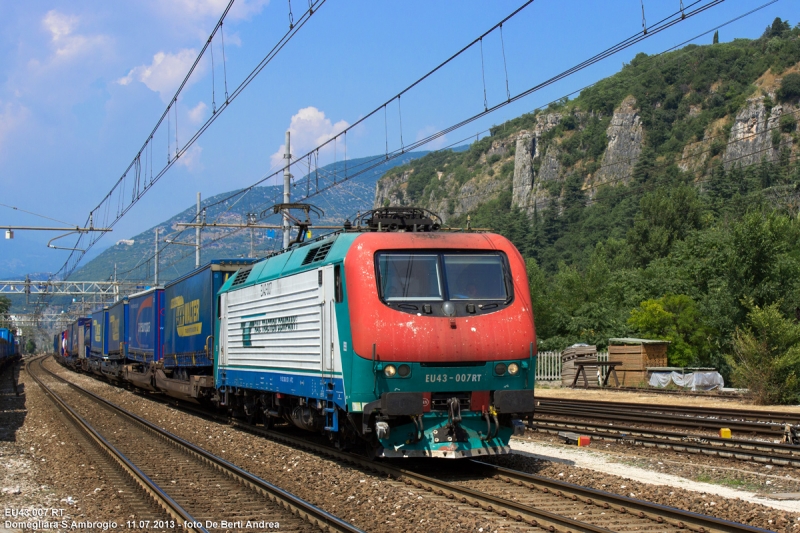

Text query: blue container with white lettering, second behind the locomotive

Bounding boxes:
[126,289,164,363]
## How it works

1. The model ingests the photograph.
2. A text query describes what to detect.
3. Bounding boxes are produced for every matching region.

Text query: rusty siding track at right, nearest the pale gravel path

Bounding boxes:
[534,419,800,467]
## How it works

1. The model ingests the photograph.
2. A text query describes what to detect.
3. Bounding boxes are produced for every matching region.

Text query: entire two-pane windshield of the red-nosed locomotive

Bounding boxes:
[376,252,508,302]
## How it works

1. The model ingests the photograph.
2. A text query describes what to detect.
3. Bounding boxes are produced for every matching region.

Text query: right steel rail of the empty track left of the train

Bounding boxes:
[37,356,364,533]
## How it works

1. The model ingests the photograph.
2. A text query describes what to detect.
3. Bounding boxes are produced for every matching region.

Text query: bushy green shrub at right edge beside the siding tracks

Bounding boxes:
[729,303,800,404]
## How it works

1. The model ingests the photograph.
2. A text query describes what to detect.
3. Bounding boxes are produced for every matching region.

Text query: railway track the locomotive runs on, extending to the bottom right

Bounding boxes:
[231,420,766,533]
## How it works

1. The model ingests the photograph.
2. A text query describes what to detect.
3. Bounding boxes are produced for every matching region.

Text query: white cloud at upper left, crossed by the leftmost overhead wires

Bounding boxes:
[117,48,204,102]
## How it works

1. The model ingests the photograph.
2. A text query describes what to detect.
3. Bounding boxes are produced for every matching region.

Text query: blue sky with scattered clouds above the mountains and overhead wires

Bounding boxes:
[0,0,800,270]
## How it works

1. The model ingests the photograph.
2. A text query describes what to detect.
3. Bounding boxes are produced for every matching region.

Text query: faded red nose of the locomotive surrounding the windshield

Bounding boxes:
[345,233,535,362]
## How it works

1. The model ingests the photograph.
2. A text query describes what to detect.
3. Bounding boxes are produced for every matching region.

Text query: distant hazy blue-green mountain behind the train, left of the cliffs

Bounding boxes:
[70,152,427,283]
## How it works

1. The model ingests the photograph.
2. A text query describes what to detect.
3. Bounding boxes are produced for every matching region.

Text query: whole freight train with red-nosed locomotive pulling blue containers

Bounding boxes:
[54,208,536,458]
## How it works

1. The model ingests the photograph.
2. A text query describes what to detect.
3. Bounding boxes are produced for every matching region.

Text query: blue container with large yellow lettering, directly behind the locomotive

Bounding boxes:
[164,259,256,368]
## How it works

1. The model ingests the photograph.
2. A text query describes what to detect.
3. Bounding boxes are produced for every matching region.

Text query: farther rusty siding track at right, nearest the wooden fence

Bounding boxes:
[537,398,800,424]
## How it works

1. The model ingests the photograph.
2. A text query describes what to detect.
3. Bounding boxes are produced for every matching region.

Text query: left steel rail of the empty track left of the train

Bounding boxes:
[25,356,208,533]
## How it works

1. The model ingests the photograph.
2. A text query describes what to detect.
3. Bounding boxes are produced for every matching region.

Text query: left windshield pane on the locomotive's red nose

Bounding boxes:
[377,253,442,301]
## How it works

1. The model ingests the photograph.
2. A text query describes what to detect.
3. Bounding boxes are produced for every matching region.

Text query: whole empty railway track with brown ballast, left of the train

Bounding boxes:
[28,359,361,532]
